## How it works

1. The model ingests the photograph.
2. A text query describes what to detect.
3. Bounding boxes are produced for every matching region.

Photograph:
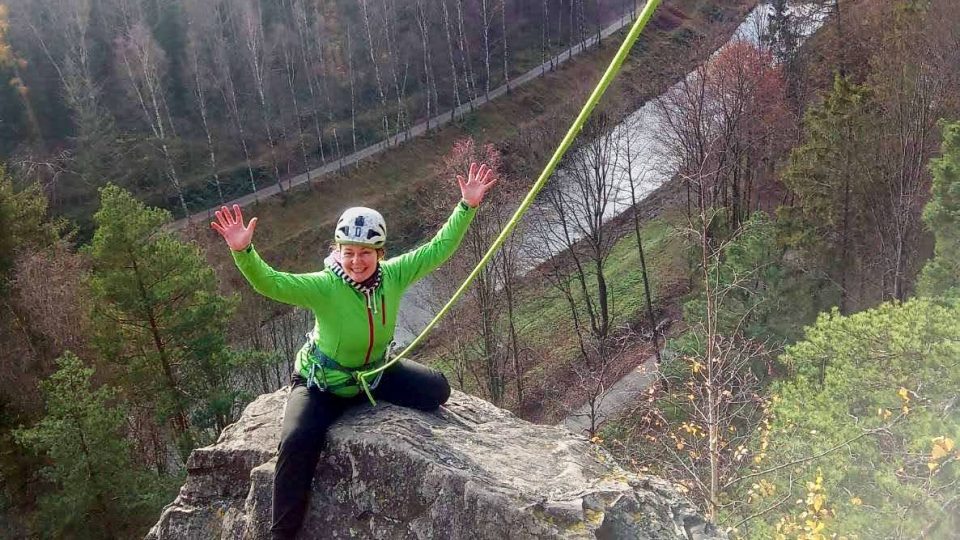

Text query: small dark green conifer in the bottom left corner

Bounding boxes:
[14,352,166,538]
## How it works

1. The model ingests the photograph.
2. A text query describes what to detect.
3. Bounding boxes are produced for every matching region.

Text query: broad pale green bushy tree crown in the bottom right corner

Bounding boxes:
[741,299,960,538]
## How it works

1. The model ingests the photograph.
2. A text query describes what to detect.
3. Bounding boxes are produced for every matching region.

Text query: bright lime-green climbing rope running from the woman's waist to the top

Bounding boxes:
[355,0,660,405]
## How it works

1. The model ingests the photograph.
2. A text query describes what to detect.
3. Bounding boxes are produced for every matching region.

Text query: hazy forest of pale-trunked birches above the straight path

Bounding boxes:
[0,0,634,227]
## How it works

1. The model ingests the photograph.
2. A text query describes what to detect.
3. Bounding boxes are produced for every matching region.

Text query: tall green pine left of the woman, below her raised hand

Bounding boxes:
[85,185,236,451]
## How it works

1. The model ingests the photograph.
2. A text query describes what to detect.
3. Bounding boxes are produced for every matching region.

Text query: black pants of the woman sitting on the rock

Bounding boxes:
[271,360,450,539]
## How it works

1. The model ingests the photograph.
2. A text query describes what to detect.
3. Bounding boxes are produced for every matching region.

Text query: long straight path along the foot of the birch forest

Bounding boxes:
[169,13,633,230]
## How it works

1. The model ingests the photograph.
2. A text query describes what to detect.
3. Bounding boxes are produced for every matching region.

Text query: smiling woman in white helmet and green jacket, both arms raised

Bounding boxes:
[210,163,496,539]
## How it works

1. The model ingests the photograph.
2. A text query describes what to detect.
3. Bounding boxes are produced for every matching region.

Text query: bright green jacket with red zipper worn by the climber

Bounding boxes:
[232,201,477,397]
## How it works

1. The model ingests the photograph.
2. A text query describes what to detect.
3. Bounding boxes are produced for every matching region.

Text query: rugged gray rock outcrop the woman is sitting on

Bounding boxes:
[147,389,722,540]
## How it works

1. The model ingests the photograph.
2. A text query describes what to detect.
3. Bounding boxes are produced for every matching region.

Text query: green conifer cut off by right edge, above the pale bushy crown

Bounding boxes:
[918,122,960,298]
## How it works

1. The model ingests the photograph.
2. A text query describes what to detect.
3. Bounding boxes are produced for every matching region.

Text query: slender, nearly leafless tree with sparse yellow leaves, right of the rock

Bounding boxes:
[608,144,777,520]
